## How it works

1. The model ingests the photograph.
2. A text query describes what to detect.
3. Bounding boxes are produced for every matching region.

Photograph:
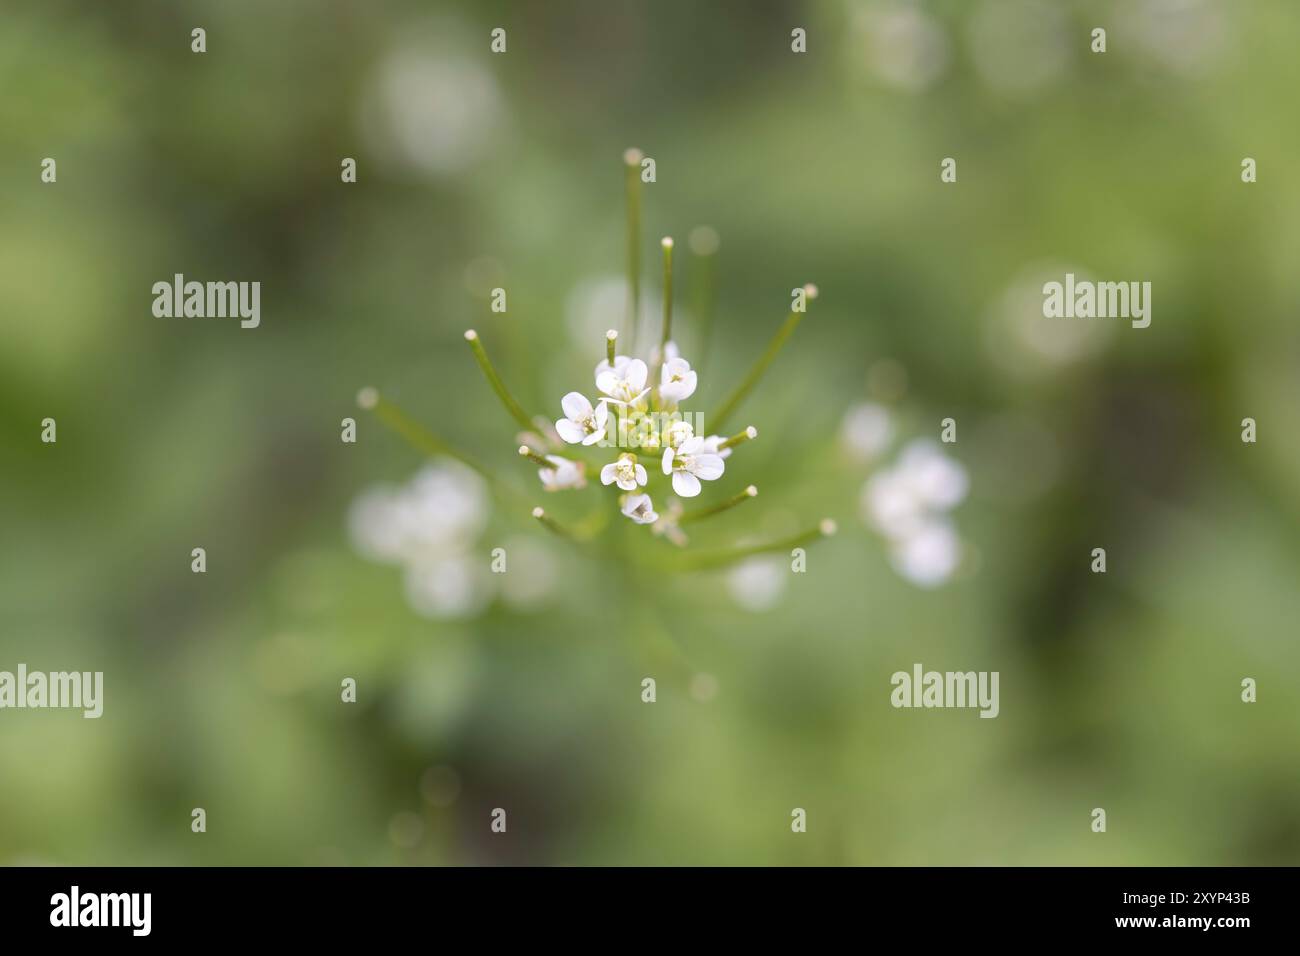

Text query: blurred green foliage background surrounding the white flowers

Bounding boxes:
[0,0,1300,865]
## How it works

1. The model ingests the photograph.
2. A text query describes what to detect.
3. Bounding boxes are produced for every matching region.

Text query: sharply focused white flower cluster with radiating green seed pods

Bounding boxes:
[358,151,835,567]
